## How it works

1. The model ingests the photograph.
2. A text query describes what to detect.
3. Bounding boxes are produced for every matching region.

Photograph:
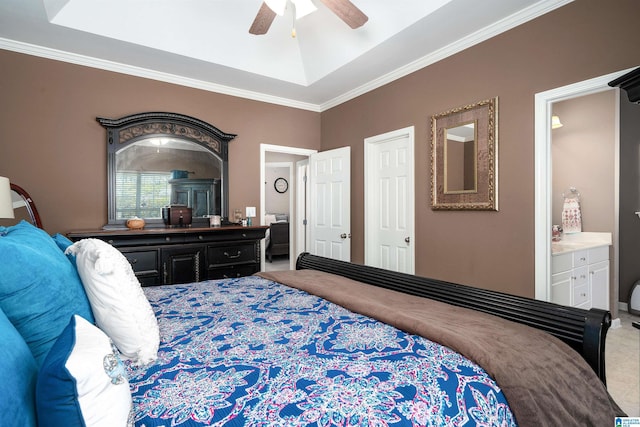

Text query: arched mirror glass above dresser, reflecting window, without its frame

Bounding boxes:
[115,137,223,220]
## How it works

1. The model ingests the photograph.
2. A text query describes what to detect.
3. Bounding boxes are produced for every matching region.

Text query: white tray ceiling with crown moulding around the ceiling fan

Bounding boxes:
[0,0,570,111]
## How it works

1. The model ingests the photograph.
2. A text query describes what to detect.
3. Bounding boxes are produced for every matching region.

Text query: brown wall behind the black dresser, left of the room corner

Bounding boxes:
[0,50,320,233]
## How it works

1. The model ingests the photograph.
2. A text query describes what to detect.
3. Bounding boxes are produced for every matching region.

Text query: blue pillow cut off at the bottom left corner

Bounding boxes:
[0,310,38,427]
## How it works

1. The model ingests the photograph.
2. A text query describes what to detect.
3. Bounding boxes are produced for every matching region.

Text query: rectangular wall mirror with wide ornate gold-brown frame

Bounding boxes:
[431,97,498,211]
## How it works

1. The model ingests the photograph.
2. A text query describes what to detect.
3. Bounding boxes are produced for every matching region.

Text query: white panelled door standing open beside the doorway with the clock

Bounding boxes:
[307,147,351,261]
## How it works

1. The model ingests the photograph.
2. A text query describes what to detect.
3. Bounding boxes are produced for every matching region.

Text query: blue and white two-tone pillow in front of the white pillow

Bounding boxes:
[36,315,132,427]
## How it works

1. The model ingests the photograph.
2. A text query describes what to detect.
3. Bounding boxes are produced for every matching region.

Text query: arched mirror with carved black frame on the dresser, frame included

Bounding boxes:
[97,112,236,229]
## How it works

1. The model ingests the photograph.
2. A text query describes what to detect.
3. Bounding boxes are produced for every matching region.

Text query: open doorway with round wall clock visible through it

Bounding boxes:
[260,144,317,271]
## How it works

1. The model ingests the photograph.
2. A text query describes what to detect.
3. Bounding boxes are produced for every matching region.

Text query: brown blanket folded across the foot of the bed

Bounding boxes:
[257,270,622,427]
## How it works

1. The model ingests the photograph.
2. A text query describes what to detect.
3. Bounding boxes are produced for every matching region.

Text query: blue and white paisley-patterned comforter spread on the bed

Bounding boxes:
[127,276,515,427]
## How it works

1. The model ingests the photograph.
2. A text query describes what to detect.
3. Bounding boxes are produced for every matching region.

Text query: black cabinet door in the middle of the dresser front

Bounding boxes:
[160,245,205,285]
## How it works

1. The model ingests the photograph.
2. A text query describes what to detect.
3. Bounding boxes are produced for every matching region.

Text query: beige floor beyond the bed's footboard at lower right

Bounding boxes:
[605,311,640,417]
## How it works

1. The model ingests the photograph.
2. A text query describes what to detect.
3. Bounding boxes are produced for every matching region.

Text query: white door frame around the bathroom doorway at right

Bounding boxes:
[534,68,633,301]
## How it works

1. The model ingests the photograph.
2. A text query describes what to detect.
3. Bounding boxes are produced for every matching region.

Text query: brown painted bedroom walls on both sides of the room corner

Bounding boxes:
[0,0,640,296]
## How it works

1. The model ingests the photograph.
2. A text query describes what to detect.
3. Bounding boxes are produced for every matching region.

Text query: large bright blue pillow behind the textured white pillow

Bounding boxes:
[0,221,94,366]
